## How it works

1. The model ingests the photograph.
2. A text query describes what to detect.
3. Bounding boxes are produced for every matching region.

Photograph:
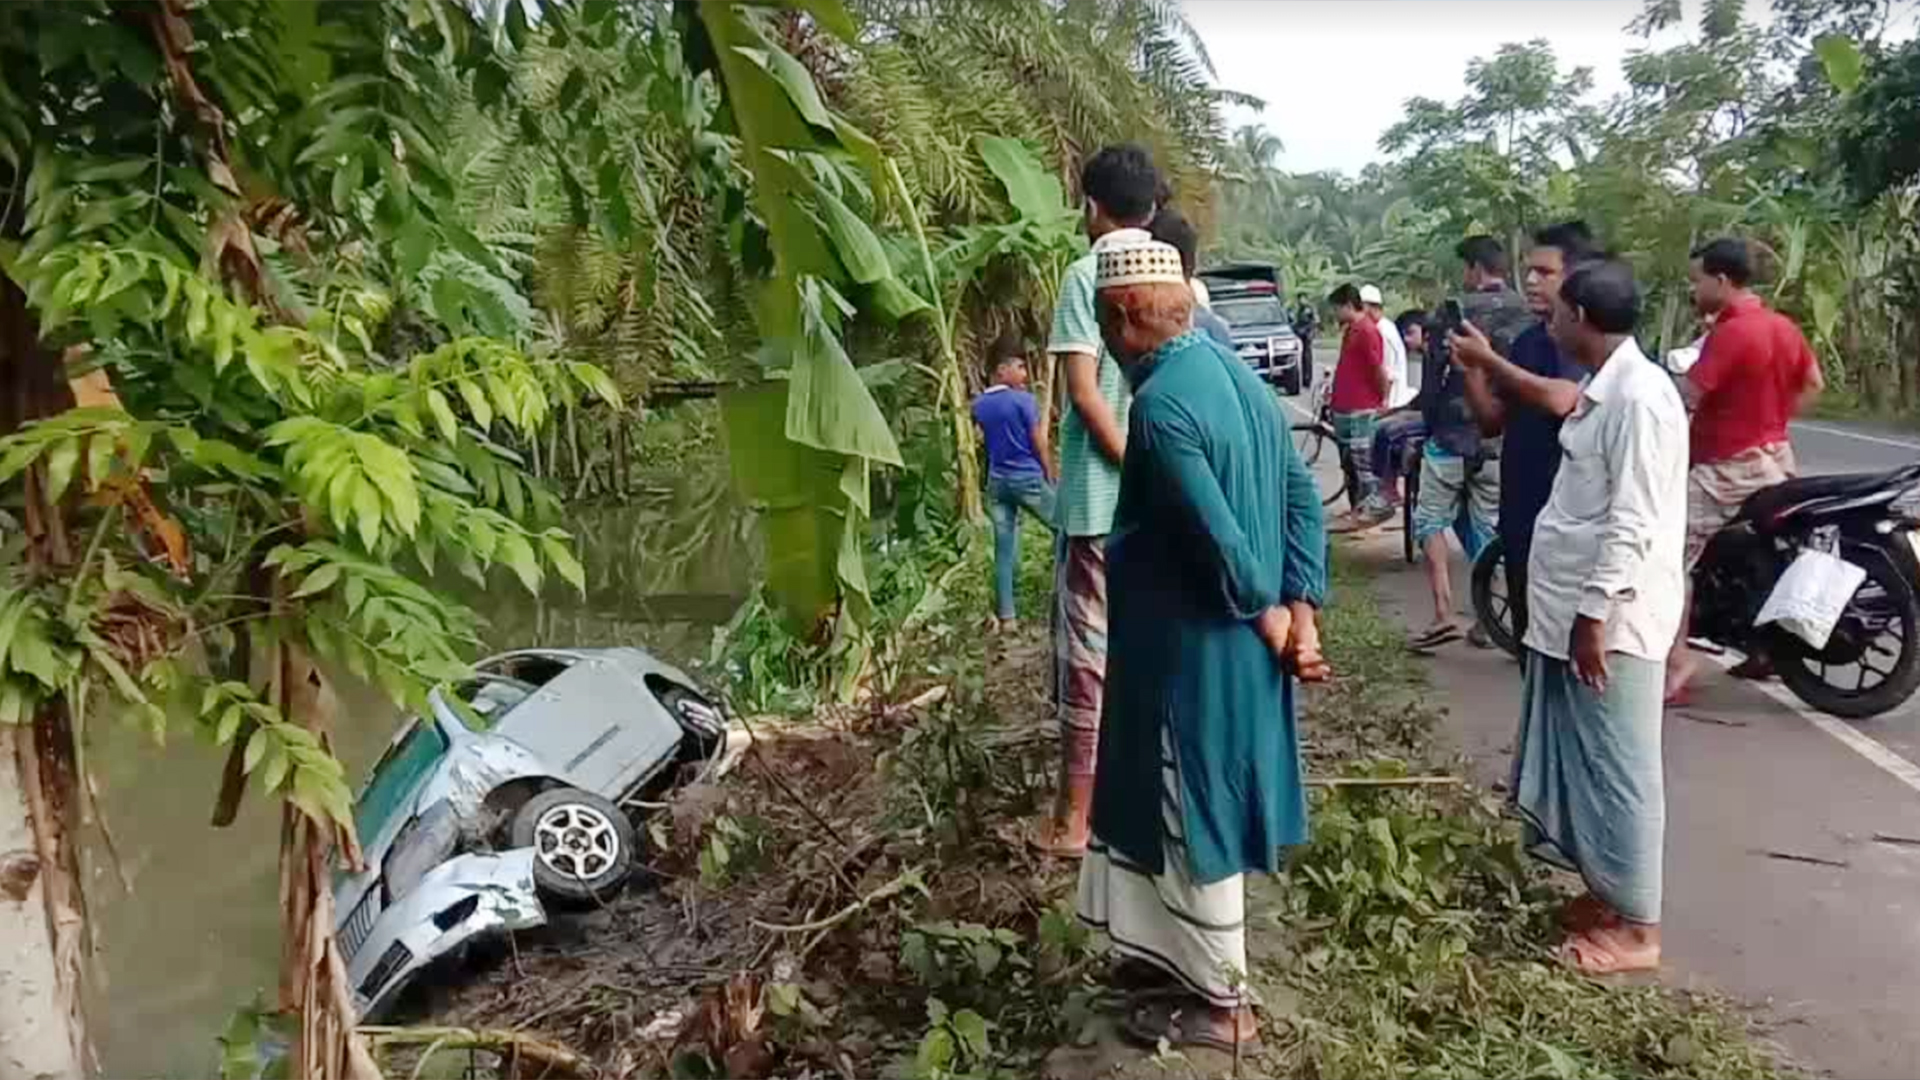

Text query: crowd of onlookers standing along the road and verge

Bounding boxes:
[973,138,1822,1047]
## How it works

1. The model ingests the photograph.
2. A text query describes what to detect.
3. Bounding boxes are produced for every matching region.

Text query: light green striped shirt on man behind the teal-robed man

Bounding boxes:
[1046,229,1146,536]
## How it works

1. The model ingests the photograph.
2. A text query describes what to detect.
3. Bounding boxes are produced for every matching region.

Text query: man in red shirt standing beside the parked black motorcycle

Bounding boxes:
[1667,238,1826,703]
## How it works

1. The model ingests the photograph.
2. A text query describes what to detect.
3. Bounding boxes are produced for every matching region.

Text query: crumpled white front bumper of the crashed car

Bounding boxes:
[340,847,547,1019]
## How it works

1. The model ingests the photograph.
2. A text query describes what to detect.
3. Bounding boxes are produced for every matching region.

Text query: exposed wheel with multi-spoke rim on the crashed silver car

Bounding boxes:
[509,788,637,905]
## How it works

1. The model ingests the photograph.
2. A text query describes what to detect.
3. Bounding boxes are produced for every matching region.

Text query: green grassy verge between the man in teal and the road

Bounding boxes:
[1254,549,1793,1080]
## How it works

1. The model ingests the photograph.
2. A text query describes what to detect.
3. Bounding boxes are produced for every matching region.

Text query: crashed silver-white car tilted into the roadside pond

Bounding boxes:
[334,648,728,1019]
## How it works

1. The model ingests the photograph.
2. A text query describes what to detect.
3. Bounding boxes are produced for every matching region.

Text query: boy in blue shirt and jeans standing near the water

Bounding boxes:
[973,336,1054,630]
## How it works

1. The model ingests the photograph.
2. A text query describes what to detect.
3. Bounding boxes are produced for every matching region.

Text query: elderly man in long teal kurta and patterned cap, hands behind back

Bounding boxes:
[1079,242,1327,1049]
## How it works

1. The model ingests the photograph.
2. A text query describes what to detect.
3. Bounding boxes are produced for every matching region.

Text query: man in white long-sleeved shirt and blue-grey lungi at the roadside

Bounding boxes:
[1482,261,1688,974]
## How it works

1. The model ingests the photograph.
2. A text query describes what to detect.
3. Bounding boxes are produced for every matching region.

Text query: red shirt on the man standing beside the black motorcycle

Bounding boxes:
[1688,296,1818,465]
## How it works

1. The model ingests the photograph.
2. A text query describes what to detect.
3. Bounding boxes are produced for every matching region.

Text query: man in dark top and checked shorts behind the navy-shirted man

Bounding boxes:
[1409,236,1534,651]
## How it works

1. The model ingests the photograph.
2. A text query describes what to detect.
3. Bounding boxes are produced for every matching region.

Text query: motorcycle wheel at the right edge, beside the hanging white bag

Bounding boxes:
[1770,542,1920,721]
